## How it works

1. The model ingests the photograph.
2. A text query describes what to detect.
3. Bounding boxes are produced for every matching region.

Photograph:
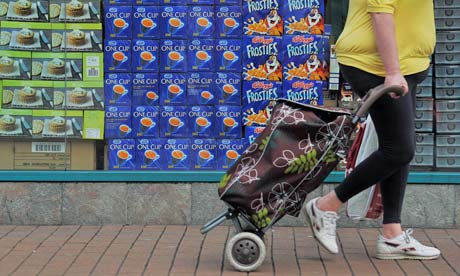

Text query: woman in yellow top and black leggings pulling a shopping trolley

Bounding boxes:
[305,0,440,259]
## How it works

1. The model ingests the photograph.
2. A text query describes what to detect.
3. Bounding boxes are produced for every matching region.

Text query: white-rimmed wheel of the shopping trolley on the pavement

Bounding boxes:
[225,232,266,272]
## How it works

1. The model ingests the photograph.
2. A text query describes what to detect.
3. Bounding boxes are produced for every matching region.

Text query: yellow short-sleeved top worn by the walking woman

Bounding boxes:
[336,0,436,76]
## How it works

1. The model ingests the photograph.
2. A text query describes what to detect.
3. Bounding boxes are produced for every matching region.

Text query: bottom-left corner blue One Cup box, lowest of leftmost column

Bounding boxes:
[108,139,136,170]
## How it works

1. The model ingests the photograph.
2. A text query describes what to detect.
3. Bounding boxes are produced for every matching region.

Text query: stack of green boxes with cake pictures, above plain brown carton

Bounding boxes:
[0,0,104,139]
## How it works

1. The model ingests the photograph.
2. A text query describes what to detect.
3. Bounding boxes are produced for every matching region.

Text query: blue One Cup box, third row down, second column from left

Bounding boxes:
[132,73,160,106]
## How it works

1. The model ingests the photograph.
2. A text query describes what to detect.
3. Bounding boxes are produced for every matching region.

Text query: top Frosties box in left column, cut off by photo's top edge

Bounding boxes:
[243,0,285,36]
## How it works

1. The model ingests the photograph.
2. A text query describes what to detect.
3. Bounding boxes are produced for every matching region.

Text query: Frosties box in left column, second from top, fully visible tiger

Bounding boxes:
[243,36,283,81]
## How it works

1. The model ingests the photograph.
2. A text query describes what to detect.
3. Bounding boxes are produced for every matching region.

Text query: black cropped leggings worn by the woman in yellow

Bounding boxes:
[335,65,427,224]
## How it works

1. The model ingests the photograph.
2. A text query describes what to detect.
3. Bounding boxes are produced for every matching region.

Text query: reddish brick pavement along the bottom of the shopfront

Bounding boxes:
[0,225,460,276]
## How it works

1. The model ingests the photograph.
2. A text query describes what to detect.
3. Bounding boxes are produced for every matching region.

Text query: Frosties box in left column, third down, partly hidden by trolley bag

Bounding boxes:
[243,81,283,126]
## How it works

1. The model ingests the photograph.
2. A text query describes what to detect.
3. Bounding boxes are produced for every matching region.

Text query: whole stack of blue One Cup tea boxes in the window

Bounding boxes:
[104,0,248,170]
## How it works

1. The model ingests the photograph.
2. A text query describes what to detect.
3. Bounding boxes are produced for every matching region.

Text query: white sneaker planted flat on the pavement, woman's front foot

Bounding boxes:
[376,229,441,260]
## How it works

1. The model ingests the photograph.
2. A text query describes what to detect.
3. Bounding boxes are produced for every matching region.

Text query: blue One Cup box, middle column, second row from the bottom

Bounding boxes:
[160,105,190,138]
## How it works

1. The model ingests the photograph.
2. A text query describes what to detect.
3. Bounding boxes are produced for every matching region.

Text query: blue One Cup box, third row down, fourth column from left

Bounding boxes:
[187,72,217,105]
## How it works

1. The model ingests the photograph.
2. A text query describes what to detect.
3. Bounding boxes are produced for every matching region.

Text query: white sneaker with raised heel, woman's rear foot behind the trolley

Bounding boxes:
[305,197,339,254]
